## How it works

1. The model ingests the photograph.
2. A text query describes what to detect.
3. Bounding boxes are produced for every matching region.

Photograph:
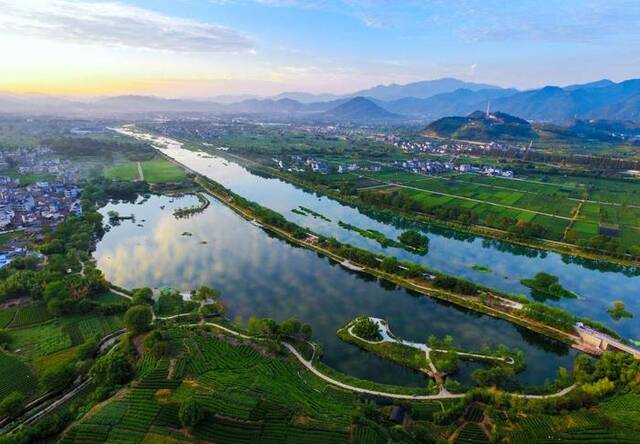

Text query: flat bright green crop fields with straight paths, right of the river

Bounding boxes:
[352,171,640,245]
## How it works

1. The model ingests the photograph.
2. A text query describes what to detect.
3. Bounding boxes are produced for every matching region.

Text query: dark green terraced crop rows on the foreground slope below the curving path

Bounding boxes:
[62,331,368,443]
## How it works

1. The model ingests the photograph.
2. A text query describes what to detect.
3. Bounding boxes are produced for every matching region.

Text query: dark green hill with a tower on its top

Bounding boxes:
[423,111,538,141]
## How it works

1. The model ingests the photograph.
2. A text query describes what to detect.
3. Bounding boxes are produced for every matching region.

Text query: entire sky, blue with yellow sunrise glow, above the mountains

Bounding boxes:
[0,0,640,98]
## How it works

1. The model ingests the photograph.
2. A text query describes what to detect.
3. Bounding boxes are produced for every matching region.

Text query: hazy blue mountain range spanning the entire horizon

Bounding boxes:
[0,78,640,122]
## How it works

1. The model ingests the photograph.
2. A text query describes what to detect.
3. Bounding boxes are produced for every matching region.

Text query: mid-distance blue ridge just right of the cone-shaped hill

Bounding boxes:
[378,88,518,119]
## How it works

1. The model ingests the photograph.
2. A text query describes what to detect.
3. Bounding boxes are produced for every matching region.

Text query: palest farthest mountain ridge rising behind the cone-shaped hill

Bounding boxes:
[351,78,500,101]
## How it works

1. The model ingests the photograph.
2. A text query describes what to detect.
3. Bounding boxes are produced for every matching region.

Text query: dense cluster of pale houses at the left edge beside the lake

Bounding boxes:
[0,176,82,232]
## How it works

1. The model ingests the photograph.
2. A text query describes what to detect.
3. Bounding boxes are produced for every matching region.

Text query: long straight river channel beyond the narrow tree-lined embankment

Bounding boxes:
[139,137,640,339]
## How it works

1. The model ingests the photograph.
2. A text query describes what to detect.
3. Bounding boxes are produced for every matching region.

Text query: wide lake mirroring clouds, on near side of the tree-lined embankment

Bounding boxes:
[95,196,575,385]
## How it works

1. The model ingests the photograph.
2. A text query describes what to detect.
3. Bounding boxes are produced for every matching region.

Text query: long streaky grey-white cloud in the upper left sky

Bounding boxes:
[0,0,253,52]
